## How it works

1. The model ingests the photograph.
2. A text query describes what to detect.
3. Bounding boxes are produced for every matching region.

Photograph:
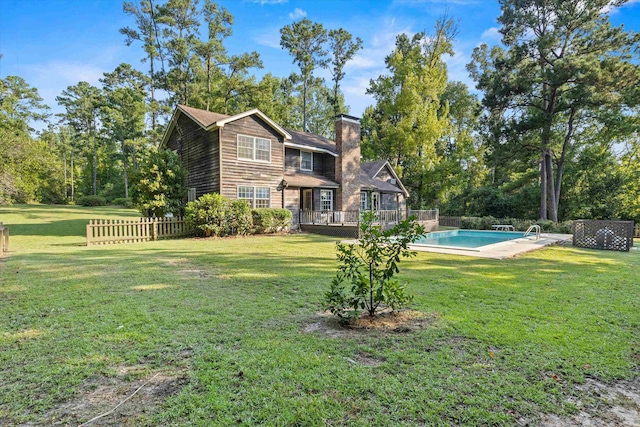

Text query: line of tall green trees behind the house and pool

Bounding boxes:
[0,0,640,226]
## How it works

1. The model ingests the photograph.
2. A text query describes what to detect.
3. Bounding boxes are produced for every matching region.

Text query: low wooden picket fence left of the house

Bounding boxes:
[87,217,193,246]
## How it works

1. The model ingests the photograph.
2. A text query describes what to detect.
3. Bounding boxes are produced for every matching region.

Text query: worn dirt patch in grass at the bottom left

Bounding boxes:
[40,365,186,426]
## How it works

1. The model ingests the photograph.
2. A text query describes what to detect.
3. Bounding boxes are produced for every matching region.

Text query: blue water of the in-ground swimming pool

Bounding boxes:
[415,230,524,248]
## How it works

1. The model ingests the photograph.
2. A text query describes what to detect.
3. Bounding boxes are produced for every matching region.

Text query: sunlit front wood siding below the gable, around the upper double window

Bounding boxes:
[220,116,284,208]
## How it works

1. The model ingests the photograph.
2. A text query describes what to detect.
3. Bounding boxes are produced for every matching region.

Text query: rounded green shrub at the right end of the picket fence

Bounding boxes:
[185,193,231,237]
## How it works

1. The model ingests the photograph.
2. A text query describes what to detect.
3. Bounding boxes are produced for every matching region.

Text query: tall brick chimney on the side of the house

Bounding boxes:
[335,114,360,211]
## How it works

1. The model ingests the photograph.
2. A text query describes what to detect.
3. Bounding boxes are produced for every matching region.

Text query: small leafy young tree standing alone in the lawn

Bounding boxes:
[324,212,425,322]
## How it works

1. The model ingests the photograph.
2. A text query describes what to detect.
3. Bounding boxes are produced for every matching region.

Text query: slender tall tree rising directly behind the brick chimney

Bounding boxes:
[328,28,362,115]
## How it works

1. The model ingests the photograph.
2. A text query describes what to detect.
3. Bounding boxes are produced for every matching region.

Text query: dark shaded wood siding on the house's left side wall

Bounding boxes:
[167,114,220,197]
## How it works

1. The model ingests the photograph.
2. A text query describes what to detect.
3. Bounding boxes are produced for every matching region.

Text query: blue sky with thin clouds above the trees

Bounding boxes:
[0,0,640,127]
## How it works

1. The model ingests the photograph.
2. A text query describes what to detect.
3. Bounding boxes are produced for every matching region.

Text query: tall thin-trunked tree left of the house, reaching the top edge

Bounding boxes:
[120,0,164,144]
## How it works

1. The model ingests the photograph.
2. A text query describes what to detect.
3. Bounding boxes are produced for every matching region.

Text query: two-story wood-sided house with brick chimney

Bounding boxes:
[161,105,408,228]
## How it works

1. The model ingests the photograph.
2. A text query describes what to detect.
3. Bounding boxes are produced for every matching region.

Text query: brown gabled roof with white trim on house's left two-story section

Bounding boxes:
[160,104,291,146]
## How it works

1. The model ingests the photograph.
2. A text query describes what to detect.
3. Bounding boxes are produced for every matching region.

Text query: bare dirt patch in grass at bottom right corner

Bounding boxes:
[538,378,640,427]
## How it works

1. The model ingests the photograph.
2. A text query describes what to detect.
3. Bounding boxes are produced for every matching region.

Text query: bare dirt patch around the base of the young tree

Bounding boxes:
[302,310,438,338]
